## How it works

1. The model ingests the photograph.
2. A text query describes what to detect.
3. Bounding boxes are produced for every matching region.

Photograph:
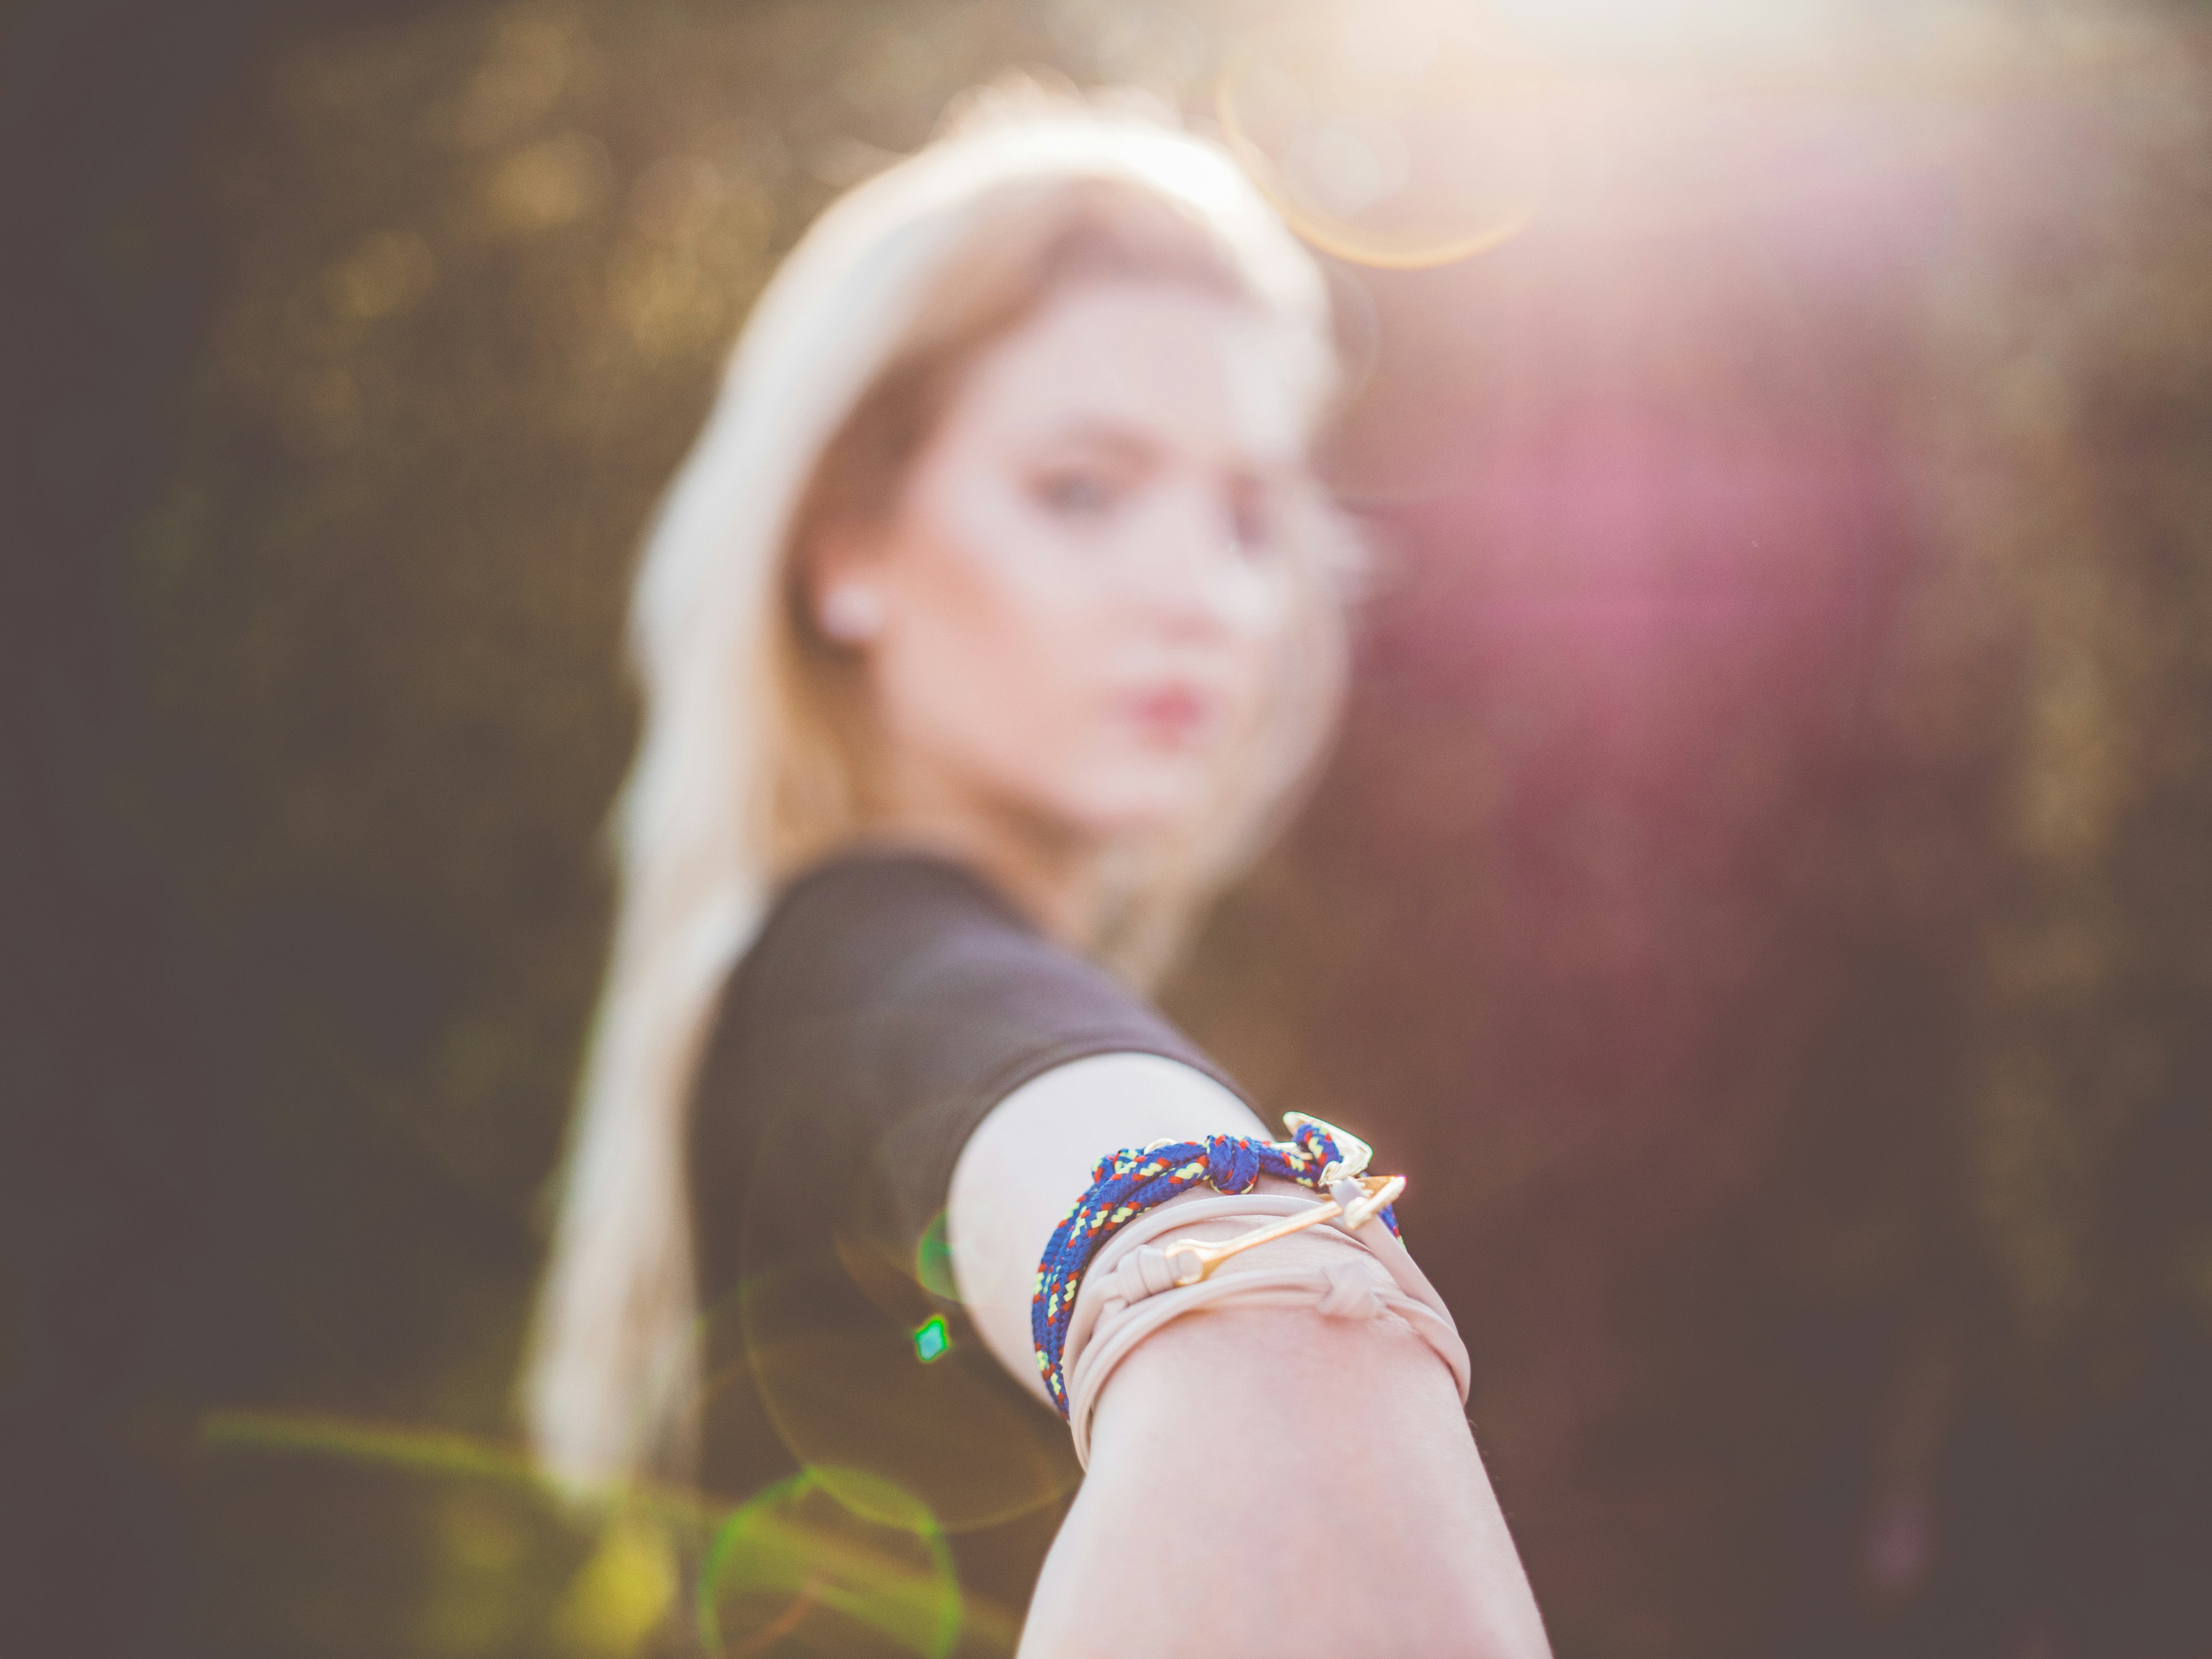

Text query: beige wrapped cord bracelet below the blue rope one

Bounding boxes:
[1062,1192,1471,1469]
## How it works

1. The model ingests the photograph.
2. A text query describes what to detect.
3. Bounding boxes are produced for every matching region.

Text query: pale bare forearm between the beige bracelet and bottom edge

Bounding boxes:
[1022,1239,1548,1659]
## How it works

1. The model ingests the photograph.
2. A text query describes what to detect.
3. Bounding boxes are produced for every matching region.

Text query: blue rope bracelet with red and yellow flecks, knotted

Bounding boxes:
[1029,1113,1398,1418]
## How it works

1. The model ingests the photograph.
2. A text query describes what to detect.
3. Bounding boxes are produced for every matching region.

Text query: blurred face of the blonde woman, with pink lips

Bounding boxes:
[814,281,1305,845]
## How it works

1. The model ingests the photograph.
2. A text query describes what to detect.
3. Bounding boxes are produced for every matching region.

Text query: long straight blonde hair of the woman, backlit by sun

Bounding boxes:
[524,95,1349,1484]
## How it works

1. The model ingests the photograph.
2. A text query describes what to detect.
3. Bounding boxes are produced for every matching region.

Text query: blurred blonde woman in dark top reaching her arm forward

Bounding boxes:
[527,102,1544,1659]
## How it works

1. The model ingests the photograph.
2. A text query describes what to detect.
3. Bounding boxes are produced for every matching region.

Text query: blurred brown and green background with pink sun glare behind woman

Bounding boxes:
[13,0,2212,1659]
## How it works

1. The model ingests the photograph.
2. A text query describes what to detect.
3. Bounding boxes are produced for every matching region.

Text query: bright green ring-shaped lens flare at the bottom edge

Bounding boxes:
[699,1469,962,1659]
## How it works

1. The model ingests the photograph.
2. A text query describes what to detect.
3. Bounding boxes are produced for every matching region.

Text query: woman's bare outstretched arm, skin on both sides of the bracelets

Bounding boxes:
[949,1055,1548,1659]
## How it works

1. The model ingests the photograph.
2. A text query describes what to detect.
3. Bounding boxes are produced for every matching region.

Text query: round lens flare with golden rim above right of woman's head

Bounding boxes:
[1217,9,1551,268]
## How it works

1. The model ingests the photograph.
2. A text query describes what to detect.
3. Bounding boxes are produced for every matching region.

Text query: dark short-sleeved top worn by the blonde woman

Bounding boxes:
[690,852,1234,1588]
